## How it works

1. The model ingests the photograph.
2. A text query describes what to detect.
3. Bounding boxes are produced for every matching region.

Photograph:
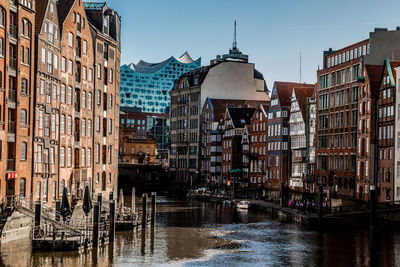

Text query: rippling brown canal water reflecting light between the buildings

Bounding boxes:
[0,197,400,266]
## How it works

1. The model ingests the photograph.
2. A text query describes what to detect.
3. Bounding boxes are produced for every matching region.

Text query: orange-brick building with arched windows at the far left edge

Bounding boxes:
[0,0,36,201]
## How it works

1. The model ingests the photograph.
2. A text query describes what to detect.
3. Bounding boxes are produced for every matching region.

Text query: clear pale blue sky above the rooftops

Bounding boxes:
[94,0,400,88]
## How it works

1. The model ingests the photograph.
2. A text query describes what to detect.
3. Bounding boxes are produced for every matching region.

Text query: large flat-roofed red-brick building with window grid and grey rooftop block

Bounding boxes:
[314,29,400,203]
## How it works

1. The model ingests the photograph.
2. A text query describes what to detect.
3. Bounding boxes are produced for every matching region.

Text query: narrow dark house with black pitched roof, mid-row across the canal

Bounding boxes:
[222,107,256,186]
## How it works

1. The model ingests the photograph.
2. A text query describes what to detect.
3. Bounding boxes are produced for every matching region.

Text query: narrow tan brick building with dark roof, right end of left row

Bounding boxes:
[84,0,121,197]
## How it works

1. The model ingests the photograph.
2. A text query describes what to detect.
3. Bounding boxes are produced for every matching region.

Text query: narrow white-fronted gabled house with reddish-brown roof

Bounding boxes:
[289,85,316,195]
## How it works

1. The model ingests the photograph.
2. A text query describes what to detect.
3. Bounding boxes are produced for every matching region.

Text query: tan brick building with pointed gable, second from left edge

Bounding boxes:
[32,0,62,205]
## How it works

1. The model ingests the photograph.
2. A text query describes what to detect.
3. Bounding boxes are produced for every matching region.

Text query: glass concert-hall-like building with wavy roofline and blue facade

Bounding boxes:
[121,52,201,113]
